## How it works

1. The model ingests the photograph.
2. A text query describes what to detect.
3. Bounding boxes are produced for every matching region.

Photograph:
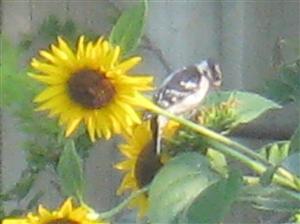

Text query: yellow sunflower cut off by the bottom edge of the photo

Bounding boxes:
[3,198,107,224]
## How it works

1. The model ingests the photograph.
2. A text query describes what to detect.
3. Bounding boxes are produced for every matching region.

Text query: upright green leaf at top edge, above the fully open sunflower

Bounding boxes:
[109,0,148,55]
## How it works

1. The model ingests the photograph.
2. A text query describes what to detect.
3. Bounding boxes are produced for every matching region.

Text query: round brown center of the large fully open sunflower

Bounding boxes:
[68,69,115,109]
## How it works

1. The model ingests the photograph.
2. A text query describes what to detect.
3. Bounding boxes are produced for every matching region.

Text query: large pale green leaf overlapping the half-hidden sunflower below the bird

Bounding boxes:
[149,152,220,223]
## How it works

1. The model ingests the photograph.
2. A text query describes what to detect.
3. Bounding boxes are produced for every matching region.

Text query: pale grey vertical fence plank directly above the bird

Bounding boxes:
[146,1,219,73]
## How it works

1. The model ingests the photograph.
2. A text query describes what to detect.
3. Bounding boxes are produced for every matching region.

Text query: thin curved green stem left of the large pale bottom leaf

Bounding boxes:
[98,186,149,219]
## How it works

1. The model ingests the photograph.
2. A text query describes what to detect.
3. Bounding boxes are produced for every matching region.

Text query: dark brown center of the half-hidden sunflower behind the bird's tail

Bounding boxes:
[134,141,162,188]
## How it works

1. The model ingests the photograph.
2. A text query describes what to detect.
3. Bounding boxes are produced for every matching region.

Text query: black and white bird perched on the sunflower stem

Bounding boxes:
[152,59,222,154]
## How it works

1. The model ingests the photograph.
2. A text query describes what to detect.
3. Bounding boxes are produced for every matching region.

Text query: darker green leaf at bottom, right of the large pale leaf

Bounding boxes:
[183,172,242,224]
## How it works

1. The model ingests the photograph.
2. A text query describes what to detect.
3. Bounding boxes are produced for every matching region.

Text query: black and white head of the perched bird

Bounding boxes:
[197,58,222,87]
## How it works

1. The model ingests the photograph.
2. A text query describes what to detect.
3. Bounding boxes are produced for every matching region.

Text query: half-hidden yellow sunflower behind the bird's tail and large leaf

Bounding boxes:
[115,121,179,218]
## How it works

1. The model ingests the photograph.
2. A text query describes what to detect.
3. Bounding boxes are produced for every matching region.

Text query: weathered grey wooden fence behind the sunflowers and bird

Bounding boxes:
[2,0,300,222]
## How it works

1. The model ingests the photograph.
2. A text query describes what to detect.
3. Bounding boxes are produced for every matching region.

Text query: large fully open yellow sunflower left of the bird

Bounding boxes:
[29,36,153,141]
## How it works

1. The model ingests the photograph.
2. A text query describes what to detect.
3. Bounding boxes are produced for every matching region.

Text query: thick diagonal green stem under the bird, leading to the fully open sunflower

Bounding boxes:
[154,107,300,191]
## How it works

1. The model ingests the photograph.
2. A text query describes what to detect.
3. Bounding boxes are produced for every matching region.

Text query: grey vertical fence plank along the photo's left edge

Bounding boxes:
[1,0,31,210]
